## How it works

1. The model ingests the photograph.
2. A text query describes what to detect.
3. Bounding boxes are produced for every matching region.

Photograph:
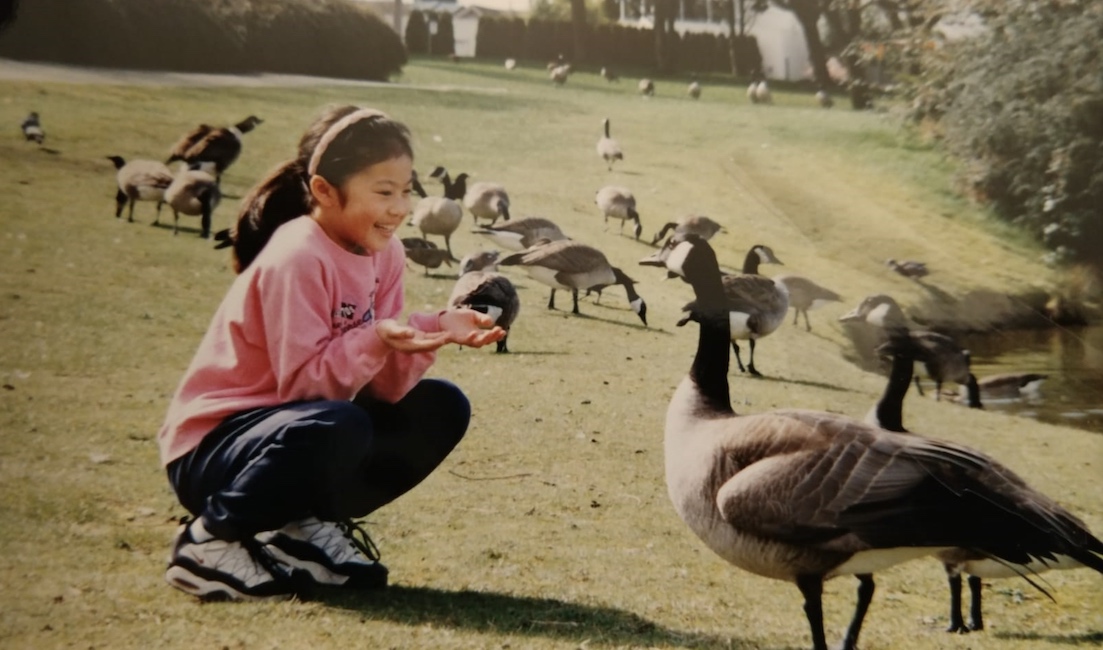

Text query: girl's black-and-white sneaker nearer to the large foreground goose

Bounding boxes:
[257,516,387,589]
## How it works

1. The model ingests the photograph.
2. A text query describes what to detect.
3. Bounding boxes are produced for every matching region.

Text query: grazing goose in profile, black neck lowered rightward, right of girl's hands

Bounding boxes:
[499,239,647,324]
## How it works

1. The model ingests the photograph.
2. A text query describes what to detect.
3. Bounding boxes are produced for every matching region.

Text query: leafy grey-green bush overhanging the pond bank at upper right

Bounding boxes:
[911,0,1103,266]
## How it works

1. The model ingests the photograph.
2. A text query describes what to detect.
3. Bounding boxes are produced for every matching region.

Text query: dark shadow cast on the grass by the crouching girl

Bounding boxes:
[319,586,757,650]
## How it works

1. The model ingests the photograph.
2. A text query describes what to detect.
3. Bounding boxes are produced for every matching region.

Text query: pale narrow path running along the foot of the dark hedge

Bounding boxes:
[0,58,506,95]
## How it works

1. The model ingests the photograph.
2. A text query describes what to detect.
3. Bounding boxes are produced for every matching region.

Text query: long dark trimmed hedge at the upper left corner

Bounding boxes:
[0,0,406,81]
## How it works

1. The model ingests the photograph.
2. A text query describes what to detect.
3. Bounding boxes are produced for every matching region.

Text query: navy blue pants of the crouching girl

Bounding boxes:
[168,380,471,541]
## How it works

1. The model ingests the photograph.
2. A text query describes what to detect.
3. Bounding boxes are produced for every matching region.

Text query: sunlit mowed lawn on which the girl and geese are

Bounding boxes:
[0,62,1103,650]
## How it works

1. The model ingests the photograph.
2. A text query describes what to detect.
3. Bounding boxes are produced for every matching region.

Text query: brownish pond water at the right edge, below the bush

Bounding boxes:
[954,326,1103,434]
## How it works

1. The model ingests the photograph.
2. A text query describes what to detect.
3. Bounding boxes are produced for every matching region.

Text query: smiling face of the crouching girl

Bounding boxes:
[310,156,414,254]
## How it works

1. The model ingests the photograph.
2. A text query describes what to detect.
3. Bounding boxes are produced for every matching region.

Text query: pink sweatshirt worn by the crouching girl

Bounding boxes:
[158,216,440,465]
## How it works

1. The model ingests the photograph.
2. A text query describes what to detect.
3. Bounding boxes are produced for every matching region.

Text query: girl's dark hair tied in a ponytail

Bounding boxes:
[231,105,414,273]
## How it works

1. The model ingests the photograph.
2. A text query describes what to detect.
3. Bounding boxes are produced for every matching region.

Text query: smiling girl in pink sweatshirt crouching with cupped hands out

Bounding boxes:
[158,107,505,599]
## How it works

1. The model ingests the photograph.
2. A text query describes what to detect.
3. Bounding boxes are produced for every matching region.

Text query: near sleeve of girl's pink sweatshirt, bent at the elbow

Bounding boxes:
[251,253,394,402]
